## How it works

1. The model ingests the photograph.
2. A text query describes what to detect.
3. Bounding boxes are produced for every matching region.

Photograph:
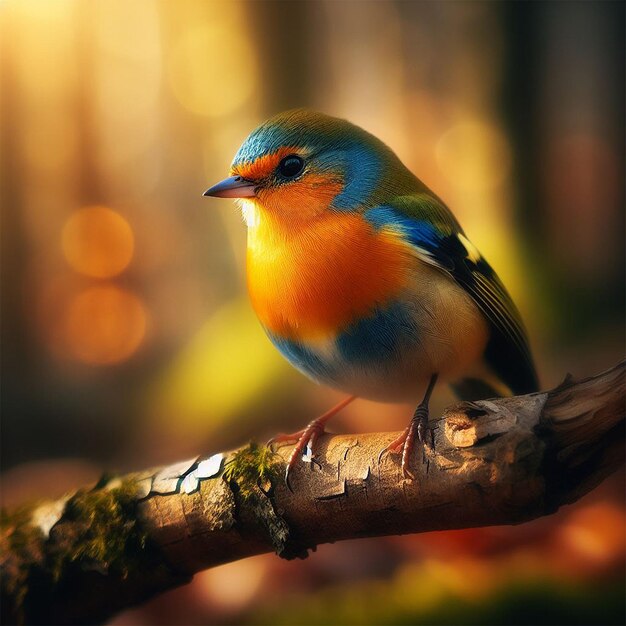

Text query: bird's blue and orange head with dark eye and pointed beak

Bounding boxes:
[204,109,420,227]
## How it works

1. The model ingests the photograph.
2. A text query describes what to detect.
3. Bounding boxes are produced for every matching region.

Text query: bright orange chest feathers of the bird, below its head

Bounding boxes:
[247,213,410,340]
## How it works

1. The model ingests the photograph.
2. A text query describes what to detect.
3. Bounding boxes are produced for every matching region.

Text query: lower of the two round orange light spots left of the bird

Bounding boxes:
[65,285,146,365]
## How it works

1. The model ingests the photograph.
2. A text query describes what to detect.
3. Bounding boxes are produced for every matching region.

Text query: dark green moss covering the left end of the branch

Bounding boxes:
[0,479,167,623]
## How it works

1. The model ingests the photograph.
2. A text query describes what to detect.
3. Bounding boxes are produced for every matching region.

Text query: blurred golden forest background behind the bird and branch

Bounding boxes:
[0,0,625,626]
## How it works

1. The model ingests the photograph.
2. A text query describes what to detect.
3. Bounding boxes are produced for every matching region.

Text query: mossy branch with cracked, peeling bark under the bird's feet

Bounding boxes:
[1,362,625,623]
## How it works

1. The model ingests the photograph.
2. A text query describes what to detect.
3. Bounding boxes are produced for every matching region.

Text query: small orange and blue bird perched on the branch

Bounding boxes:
[204,109,537,484]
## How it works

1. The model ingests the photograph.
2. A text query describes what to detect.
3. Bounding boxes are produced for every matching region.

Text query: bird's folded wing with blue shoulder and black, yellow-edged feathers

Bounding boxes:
[366,193,538,394]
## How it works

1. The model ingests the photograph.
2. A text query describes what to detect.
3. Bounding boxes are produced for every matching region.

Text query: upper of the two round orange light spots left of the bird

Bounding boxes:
[62,206,134,278]
